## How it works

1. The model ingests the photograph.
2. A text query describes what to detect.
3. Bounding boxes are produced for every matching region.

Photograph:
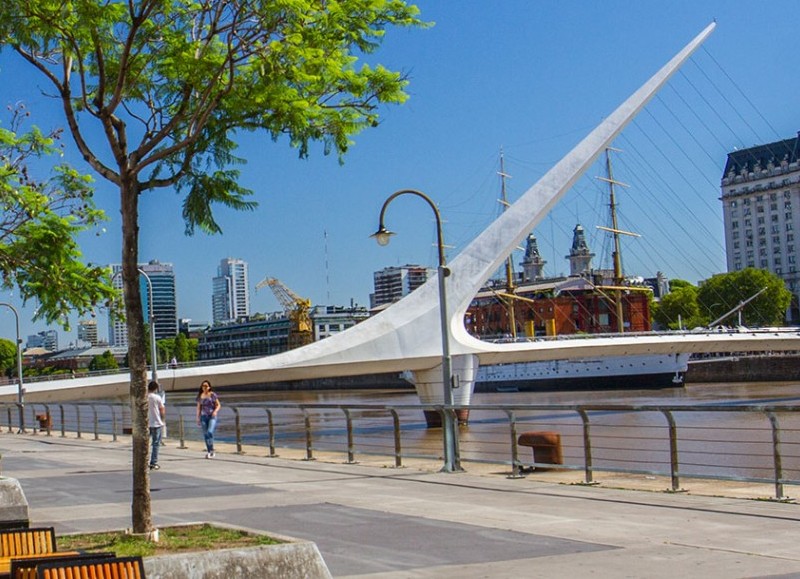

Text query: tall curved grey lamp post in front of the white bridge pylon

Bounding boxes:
[370,189,461,472]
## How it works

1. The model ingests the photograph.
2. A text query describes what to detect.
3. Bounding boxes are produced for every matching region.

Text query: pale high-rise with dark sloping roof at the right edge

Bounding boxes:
[721,134,800,322]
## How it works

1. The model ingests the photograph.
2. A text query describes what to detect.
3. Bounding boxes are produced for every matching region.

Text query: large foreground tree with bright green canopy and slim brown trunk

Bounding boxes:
[0,0,421,533]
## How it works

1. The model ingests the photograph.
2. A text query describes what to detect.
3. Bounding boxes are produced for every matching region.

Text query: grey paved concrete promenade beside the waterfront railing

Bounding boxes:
[0,433,800,578]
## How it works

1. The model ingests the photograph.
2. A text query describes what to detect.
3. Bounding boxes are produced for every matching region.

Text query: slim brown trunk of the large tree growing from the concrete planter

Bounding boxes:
[120,177,152,533]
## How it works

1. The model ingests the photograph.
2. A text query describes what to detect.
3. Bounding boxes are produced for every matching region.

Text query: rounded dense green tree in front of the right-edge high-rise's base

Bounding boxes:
[697,267,792,327]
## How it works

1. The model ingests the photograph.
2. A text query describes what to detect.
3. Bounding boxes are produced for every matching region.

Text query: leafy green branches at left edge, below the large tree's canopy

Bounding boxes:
[0,106,114,326]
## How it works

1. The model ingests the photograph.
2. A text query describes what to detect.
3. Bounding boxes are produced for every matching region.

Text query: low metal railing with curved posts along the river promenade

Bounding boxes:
[0,402,800,499]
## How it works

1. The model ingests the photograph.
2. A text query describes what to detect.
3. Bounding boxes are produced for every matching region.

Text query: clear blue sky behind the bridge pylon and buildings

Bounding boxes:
[0,0,800,346]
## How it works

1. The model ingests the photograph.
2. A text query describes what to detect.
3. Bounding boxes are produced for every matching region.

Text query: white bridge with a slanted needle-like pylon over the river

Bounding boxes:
[6,23,800,404]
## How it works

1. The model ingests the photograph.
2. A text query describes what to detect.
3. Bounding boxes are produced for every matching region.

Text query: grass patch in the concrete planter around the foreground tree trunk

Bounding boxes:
[58,524,283,557]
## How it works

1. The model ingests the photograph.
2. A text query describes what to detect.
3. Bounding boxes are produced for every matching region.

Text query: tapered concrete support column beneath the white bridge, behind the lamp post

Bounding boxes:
[412,354,478,428]
